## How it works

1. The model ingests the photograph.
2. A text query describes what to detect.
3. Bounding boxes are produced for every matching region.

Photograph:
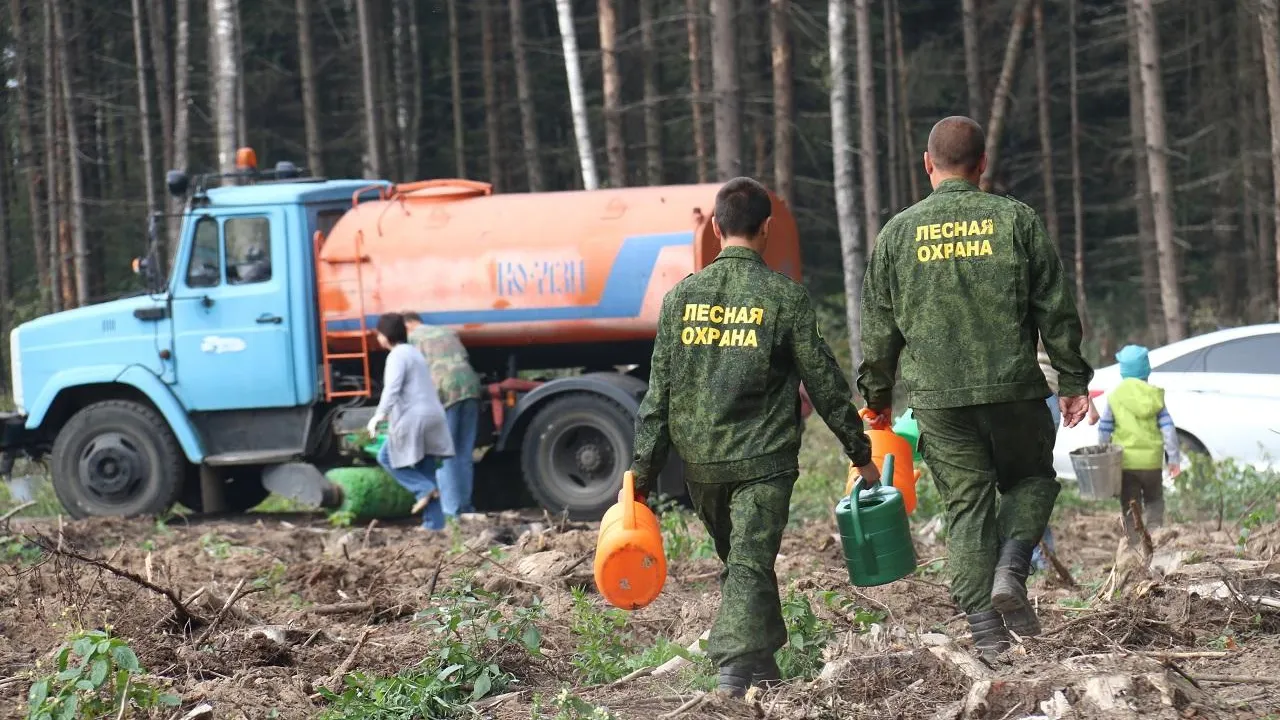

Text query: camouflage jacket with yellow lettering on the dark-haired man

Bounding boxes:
[632,247,870,489]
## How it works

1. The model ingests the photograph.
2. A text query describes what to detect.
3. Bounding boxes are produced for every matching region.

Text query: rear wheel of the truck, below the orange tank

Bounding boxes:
[521,393,635,520]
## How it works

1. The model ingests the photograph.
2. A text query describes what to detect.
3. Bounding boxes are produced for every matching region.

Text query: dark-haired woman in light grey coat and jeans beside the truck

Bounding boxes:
[369,313,453,530]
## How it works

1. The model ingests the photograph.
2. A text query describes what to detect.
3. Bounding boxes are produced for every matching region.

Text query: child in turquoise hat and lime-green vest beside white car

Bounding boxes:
[1098,345,1181,542]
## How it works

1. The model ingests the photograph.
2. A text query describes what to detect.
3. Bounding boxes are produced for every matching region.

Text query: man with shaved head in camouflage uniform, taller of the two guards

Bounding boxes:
[858,117,1093,657]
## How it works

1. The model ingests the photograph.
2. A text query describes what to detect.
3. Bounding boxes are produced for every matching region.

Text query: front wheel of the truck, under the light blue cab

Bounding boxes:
[52,400,187,518]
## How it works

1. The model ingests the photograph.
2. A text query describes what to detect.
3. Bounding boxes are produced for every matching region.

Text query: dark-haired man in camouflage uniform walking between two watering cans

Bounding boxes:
[632,178,879,697]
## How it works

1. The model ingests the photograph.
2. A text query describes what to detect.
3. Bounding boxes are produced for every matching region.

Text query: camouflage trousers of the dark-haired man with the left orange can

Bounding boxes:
[686,465,797,667]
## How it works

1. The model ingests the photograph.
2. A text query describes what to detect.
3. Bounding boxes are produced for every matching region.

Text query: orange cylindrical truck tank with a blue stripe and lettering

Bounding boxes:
[314,179,800,359]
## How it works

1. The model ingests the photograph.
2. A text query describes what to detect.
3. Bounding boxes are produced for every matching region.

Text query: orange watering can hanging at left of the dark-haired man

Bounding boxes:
[595,470,667,610]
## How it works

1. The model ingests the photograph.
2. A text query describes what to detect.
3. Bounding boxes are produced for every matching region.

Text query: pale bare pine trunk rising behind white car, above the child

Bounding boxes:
[1126,1,1165,345]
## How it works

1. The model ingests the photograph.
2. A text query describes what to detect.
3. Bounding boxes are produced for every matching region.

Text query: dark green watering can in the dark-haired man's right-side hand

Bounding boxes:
[836,455,915,588]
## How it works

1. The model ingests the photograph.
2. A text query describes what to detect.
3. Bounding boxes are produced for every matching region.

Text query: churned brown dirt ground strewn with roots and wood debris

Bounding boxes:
[0,499,1280,719]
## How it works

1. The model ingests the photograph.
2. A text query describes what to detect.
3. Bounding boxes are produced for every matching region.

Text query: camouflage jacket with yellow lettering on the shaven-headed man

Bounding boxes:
[858,179,1093,410]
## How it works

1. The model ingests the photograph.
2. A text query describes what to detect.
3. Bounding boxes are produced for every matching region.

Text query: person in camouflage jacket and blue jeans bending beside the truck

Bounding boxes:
[402,313,483,518]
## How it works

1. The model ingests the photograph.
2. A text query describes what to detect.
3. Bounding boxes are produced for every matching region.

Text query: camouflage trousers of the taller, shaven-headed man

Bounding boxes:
[915,400,1060,614]
